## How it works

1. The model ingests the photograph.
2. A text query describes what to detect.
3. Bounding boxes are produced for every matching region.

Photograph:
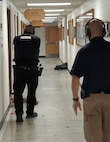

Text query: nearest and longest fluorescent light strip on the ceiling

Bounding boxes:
[27,2,71,6]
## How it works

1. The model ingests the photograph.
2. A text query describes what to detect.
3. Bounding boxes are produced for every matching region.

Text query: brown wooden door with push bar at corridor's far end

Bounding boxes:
[45,26,59,55]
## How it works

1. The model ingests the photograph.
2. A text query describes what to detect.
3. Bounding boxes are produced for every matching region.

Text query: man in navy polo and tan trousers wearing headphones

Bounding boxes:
[70,18,110,142]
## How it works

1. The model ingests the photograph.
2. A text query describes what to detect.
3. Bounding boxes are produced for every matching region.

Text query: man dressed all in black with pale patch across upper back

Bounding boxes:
[13,25,40,122]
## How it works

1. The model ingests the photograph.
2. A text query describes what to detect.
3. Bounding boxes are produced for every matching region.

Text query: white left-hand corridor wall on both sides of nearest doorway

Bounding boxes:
[0,0,27,122]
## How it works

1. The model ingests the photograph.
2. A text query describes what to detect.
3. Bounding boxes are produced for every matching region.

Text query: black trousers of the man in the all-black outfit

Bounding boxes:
[13,66,38,115]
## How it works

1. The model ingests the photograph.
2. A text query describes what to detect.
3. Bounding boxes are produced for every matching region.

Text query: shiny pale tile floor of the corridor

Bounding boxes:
[0,58,85,142]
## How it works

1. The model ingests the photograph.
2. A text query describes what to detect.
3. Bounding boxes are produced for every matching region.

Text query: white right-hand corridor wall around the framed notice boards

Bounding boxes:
[60,0,110,70]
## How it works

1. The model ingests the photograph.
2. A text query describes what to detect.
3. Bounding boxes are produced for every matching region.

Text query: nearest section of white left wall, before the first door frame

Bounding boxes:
[0,0,9,120]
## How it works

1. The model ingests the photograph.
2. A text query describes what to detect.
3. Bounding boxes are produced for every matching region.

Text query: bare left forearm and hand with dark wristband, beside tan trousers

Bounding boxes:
[72,75,82,115]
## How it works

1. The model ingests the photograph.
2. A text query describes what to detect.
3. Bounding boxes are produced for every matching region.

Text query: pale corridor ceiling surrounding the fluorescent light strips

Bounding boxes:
[11,0,87,22]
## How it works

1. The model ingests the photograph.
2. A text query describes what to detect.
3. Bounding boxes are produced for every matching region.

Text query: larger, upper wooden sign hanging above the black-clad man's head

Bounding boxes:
[24,9,45,20]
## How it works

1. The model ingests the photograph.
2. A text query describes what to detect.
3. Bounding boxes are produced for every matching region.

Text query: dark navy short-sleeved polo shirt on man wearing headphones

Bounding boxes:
[70,37,110,93]
